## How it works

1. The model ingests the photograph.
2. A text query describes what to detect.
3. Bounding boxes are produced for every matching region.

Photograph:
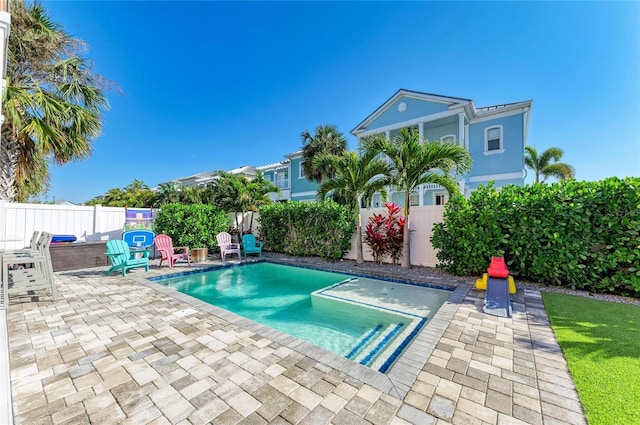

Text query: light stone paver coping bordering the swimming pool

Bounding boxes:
[140,259,471,399]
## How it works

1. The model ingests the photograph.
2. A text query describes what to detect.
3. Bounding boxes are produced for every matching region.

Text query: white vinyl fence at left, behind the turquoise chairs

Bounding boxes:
[0,201,152,249]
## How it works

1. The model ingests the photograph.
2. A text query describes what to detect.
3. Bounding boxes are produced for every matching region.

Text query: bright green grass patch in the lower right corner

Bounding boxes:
[542,292,640,425]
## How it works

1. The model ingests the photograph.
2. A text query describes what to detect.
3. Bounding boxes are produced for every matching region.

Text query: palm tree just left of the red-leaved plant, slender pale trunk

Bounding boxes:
[314,150,391,264]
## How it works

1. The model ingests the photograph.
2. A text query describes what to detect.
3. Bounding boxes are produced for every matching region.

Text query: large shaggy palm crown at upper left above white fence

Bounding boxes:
[0,0,109,202]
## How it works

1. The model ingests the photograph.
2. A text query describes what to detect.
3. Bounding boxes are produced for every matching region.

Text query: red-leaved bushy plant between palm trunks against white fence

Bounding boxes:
[364,203,404,264]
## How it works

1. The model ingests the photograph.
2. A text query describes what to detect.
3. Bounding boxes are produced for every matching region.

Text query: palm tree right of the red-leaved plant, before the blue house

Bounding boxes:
[363,128,471,267]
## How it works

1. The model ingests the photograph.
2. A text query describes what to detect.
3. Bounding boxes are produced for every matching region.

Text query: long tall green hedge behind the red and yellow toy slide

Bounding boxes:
[431,177,640,297]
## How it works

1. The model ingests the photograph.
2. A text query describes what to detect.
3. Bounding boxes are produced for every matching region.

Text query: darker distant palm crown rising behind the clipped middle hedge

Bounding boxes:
[300,124,347,184]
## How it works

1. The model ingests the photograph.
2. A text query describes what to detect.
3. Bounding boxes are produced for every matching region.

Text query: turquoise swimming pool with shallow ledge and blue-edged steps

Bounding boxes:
[152,262,451,372]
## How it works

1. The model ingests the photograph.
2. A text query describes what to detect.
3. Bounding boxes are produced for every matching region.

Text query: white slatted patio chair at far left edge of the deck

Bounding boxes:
[2,232,57,308]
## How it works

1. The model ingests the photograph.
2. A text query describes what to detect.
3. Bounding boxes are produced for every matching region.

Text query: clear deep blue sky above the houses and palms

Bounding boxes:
[43,1,640,202]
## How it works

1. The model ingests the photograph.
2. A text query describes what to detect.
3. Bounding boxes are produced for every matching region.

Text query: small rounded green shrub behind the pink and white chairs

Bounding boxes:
[154,204,231,250]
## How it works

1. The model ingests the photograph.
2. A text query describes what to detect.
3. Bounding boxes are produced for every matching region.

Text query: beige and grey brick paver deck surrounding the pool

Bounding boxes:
[2,255,586,425]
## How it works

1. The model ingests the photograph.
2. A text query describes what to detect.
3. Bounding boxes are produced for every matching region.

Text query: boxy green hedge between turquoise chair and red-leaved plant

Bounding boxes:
[258,201,356,260]
